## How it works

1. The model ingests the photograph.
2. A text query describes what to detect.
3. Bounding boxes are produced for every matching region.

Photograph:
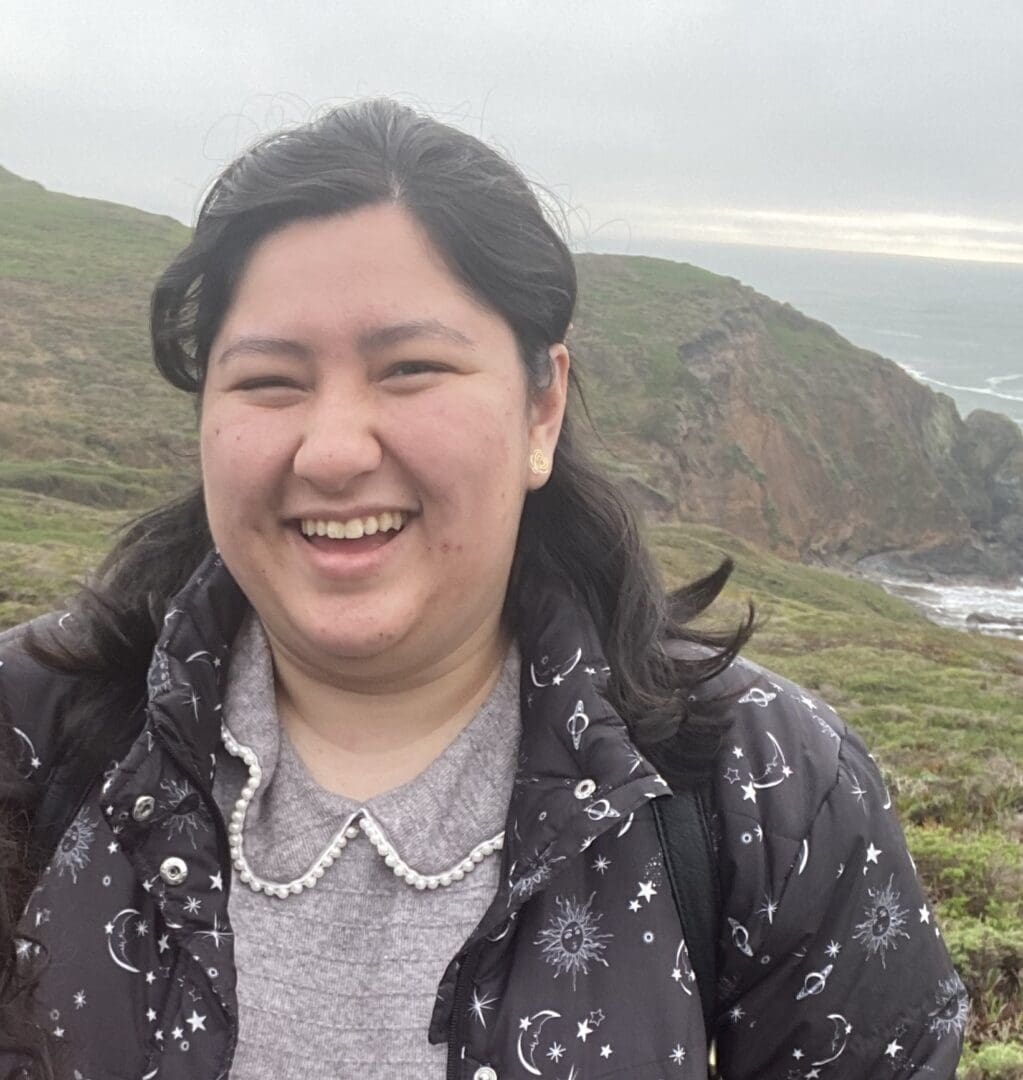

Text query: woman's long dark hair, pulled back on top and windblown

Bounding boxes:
[2,100,753,1075]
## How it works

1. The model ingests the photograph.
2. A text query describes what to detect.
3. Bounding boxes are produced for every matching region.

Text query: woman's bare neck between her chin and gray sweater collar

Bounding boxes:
[268,626,509,801]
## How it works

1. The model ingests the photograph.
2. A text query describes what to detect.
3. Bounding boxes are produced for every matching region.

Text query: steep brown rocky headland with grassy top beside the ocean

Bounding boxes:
[576,256,1023,577]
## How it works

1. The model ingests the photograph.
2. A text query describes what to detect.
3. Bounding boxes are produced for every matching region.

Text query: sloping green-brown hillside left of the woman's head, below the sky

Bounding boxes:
[0,164,193,490]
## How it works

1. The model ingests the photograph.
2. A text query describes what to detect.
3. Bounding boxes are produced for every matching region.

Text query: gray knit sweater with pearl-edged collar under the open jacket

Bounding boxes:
[214,617,520,1080]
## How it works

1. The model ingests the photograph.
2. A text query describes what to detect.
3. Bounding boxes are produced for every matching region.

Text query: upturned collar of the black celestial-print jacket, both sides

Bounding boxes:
[144,553,670,911]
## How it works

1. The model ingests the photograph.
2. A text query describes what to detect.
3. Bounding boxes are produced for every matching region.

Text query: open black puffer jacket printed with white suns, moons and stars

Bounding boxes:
[0,555,967,1080]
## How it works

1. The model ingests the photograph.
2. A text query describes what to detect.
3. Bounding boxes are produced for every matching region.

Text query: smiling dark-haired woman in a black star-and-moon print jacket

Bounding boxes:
[0,102,966,1080]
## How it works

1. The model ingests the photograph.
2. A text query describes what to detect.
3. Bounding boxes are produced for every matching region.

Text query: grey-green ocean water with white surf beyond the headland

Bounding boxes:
[596,242,1023,640]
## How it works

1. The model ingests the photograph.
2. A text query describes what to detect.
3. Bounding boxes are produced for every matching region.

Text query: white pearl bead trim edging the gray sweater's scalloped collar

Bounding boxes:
[220,726,504,900]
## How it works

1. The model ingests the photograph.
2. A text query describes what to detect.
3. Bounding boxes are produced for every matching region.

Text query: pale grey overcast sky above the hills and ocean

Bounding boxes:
[8,0,1023,262]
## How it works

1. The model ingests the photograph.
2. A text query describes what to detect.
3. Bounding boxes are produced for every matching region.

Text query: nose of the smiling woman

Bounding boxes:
[293,390,383,490]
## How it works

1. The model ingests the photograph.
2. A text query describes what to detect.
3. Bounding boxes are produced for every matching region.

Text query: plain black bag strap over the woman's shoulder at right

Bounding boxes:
[650,784,721,1045]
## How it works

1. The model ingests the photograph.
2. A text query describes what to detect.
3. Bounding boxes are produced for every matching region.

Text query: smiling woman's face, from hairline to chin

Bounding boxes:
[200,204,568,674]
